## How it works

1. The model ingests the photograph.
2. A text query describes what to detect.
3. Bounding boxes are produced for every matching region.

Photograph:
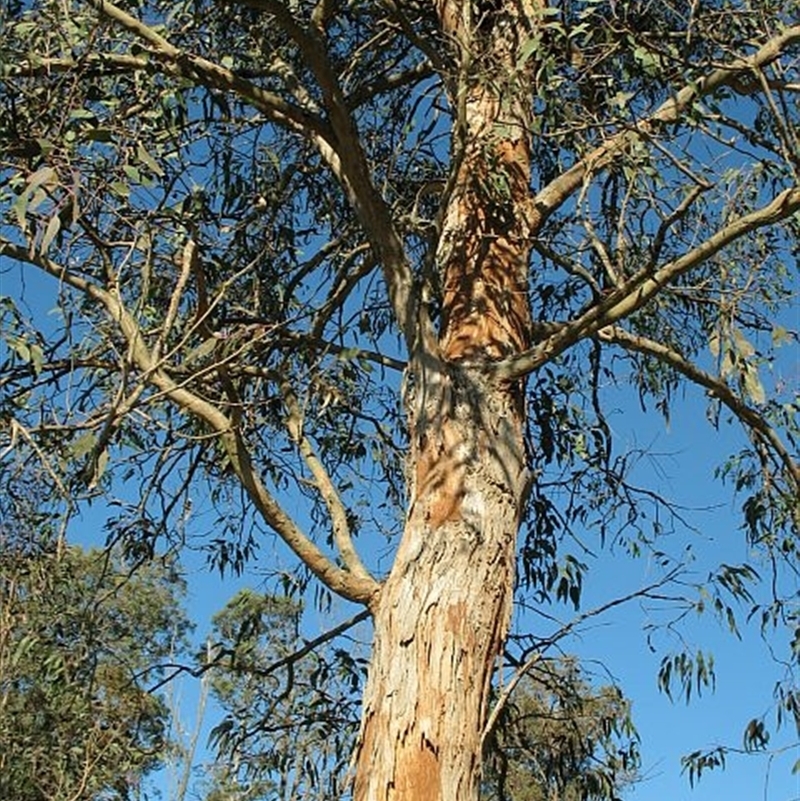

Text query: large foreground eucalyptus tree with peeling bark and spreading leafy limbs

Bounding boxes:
[0,0,800,801]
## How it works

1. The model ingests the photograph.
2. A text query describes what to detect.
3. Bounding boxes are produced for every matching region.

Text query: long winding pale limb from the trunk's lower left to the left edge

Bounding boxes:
[0,237,379,603]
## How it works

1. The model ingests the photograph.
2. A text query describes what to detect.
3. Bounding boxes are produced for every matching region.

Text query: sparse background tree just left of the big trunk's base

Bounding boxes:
[205,590,364,801]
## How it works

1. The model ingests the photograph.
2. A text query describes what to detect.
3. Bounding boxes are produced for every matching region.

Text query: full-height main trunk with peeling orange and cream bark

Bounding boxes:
[354,14,530,801]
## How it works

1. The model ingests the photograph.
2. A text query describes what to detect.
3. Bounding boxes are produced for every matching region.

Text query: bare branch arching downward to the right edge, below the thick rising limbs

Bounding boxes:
[597,326,800,494]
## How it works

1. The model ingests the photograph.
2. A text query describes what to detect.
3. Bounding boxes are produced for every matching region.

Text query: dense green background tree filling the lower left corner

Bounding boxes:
[0,462,186,801]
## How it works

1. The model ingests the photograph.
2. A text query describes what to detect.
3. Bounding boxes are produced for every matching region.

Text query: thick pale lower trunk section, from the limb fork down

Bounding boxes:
[355,368,527,801]
